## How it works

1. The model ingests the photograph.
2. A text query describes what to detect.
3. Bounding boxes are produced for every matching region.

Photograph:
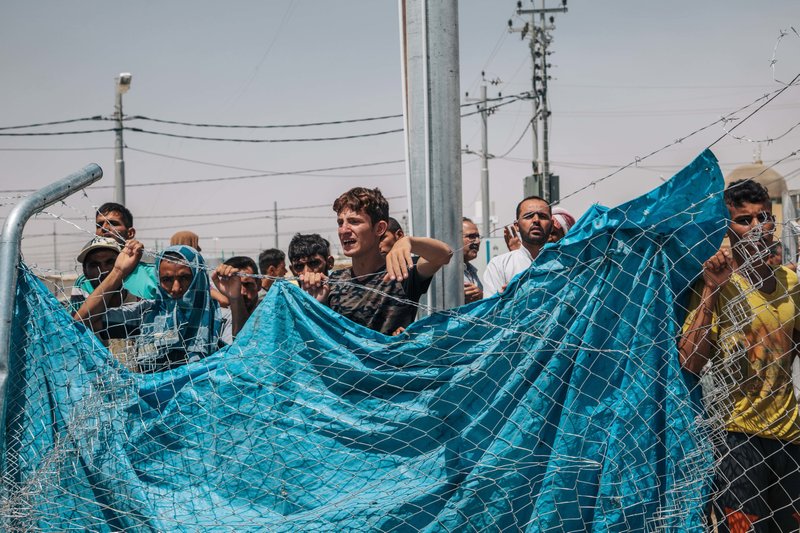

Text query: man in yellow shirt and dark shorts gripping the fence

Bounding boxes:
[678,180,800,533]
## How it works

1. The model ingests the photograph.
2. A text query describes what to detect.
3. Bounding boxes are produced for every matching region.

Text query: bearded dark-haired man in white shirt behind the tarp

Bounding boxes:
[483,196,553,297]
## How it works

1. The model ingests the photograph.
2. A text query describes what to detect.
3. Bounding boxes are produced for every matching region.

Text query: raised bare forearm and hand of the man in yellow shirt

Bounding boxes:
[678,250,732,374]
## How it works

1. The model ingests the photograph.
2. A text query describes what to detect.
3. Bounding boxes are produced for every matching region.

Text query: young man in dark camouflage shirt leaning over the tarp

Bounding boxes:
[300,187,453,335]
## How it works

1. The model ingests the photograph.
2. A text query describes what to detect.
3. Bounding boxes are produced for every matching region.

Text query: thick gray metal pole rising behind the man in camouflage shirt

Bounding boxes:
[400,0,464,309]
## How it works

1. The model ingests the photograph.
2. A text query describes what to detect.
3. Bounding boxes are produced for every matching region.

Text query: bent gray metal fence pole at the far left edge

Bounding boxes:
[0,163,103,474]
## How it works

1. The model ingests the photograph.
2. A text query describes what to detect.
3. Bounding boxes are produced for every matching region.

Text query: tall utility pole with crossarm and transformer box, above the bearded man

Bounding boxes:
[508,0,567,203]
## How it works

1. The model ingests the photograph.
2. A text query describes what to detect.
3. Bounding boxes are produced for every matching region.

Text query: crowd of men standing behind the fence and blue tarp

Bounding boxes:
[65,180,800,532]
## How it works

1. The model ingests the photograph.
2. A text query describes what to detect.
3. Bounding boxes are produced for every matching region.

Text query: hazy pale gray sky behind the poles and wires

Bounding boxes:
[0,0,800,270]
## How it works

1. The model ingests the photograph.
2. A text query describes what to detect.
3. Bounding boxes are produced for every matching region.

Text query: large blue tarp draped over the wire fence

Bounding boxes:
[3,151,726,531]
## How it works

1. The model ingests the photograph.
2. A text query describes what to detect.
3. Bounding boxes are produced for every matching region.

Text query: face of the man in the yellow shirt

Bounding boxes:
[728,202,775,260]
